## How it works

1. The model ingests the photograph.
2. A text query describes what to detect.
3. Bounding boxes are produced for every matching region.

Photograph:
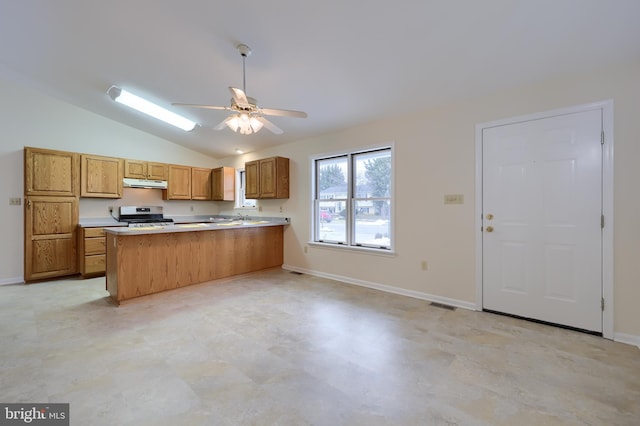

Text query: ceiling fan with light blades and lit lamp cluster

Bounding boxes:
[172,44,307,135]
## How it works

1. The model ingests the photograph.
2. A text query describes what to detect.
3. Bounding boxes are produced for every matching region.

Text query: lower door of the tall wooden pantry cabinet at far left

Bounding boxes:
[24,196,78,282]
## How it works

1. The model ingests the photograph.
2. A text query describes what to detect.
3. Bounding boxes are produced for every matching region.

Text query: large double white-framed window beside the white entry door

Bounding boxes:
[313,147,393,250]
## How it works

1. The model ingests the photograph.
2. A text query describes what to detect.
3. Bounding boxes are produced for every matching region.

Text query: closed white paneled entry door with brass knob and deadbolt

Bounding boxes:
[482,110,602,332]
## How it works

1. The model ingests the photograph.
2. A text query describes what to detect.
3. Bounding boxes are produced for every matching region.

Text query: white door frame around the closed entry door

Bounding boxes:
[475,99,614,339]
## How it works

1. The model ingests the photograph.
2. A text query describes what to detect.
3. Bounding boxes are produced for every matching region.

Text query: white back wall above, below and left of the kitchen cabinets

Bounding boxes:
[0,79,218,284]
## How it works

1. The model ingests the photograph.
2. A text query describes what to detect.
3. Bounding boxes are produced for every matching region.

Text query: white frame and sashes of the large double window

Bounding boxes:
[308,143,396,256]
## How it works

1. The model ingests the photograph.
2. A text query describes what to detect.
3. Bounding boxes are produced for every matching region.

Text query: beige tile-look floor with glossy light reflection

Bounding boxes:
[0,269,640,426]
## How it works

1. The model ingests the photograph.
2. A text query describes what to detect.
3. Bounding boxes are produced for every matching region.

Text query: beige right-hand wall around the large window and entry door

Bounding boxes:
[222,59,640,344]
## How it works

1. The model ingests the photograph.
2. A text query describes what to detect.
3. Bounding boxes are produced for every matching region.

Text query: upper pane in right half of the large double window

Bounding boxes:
[353,149,391,198]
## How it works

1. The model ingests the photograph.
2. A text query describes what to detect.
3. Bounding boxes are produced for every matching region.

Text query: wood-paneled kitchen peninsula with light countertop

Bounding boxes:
[105,218,289,304]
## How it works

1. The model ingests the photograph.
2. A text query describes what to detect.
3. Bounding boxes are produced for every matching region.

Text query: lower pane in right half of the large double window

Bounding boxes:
[354,199,391,248]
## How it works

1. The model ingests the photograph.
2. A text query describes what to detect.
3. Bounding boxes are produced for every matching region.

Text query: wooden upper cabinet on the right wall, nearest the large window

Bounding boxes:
[245,157,289,199]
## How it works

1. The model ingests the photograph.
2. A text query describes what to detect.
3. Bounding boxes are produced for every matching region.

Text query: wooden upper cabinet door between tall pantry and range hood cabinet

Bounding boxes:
[80,154,124,198]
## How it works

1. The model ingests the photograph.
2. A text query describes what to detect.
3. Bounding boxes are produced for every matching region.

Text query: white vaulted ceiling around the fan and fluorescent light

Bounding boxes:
[0,0,640,157]
